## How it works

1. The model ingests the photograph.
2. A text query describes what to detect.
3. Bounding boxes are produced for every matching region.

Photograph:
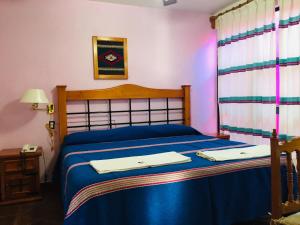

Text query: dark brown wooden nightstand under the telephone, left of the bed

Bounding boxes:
[0,147,42,205]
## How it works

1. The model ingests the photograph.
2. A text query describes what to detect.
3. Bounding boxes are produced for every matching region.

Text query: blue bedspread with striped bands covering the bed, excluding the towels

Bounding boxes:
[60,127,270,225]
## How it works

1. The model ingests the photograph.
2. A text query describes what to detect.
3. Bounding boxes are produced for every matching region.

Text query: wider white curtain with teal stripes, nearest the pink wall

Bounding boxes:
[216,0,276,144]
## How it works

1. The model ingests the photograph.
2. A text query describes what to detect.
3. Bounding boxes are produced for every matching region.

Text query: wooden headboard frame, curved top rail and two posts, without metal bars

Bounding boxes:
[56,84,191,143]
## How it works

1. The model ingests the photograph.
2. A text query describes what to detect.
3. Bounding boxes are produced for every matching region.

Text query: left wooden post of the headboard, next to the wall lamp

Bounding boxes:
[56,85,67,144]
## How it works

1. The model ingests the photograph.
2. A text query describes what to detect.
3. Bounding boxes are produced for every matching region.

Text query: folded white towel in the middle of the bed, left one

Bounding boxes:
[90,152,191,173]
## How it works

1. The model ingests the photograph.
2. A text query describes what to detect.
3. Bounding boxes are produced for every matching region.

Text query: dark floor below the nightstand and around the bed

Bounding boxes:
[0,185,269,225]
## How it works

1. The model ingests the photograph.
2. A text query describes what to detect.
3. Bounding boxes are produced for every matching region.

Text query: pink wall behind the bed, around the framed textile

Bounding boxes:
[0,0,216,179]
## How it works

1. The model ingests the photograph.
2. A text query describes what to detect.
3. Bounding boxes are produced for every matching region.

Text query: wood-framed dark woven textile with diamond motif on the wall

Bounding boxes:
[93,36,128,80]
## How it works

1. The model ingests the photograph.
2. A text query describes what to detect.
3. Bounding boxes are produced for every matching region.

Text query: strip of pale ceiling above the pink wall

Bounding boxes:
[95,0,237,14]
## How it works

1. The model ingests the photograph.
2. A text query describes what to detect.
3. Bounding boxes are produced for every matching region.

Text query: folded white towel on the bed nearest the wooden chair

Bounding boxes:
[196,145,271,161]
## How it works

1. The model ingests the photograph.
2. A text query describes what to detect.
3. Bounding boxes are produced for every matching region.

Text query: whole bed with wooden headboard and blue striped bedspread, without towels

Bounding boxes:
[57,85,271,225]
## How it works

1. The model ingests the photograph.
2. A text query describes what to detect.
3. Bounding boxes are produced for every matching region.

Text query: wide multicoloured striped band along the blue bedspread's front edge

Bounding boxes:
[65,158,270,219]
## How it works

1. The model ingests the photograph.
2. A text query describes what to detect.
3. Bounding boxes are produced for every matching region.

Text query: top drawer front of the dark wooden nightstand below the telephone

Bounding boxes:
[4,158,38,173]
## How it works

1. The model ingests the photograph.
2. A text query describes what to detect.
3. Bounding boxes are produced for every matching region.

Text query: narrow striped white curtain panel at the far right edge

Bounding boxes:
[279,0,300,139]
